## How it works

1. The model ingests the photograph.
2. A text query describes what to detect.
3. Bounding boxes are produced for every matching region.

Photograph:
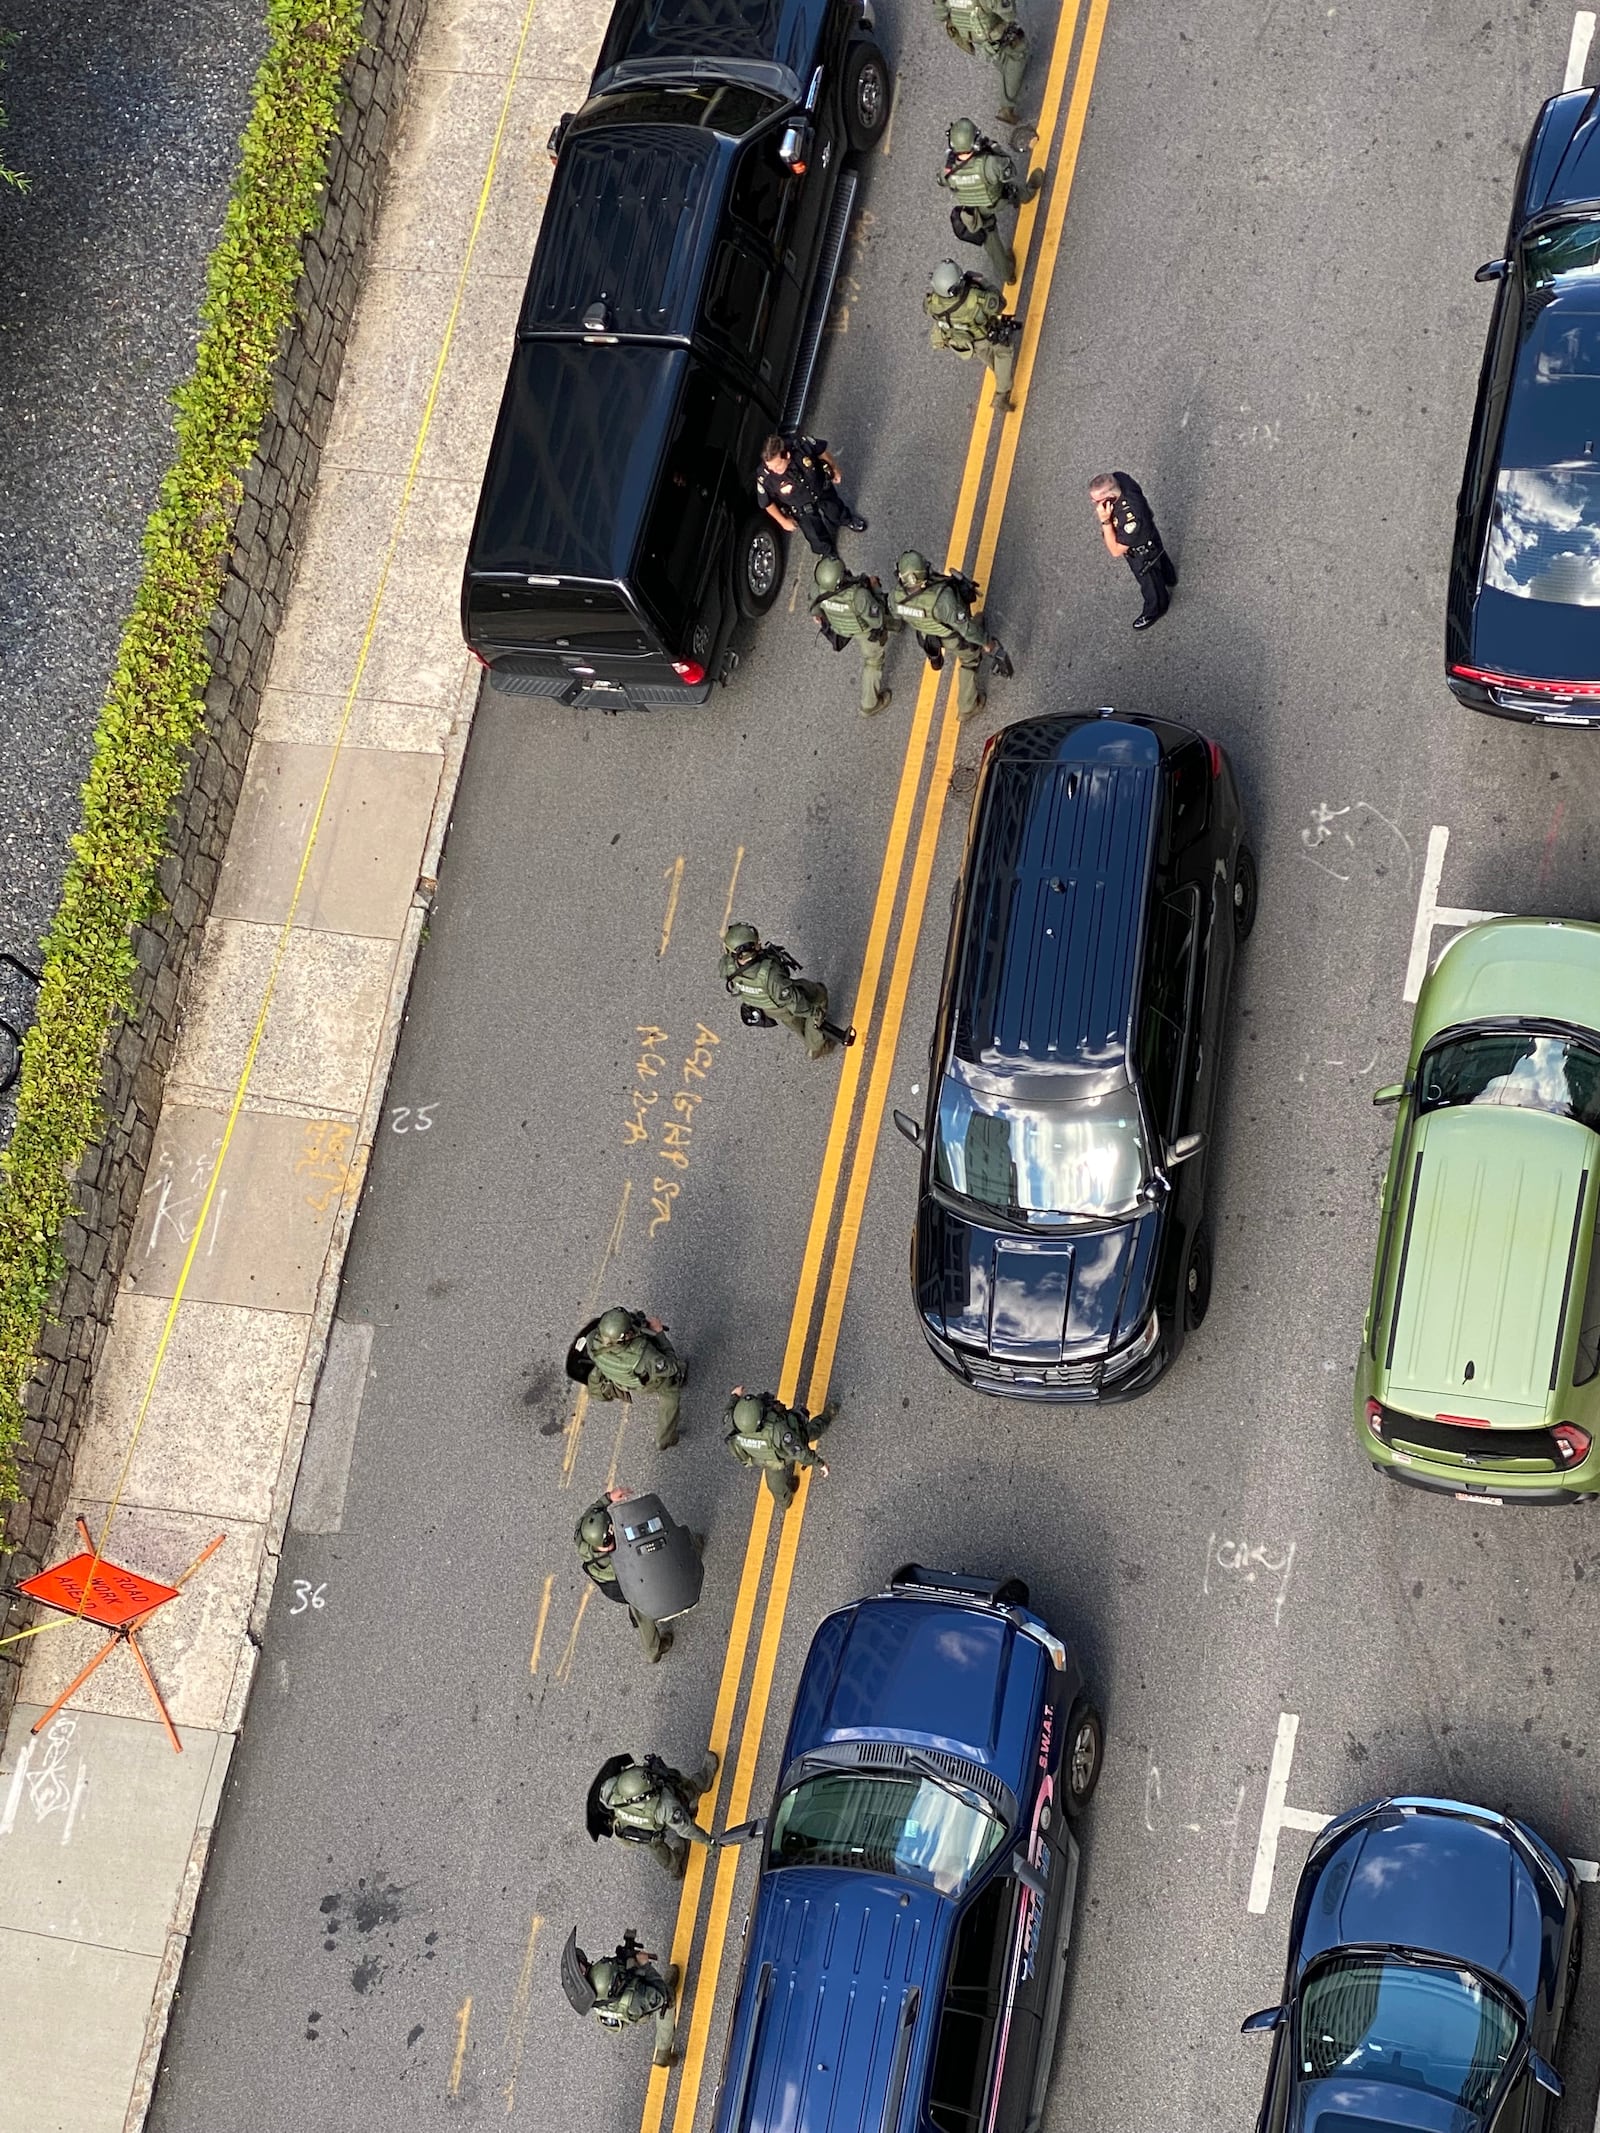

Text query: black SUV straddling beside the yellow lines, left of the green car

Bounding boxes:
[894,710,1257,1399]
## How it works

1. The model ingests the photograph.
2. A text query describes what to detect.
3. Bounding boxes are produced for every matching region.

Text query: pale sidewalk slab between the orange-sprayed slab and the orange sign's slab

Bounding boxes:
[73,1288,311,1525]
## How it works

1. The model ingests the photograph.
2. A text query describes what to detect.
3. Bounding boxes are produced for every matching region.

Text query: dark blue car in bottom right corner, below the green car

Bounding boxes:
[1244,1798,1581,2133]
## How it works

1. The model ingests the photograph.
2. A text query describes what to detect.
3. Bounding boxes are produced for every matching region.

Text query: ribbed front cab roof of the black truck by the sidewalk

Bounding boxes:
[516,126,732,341]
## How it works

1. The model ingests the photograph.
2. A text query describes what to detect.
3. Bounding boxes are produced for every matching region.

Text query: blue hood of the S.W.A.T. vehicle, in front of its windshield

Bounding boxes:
[783,1598,1047,1798]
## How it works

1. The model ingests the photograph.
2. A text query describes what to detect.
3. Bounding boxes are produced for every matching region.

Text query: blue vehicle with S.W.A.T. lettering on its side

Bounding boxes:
[713,1566,1103,2133]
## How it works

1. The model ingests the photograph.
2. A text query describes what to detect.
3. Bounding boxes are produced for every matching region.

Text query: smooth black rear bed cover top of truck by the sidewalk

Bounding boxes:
[467,339,691,582]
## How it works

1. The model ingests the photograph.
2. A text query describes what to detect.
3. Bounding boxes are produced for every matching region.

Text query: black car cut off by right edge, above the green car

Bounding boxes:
[1444,90,1600,725]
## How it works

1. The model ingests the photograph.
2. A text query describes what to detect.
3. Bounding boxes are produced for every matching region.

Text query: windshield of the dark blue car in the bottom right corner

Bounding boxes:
[1299,1956,1521,2112]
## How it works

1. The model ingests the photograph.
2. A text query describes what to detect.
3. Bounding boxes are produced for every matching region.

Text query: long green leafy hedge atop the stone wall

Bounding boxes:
[0,0,363,1502]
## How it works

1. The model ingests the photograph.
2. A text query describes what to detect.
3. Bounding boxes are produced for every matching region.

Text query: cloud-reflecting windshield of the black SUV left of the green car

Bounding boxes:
[934,1075,1146,1216]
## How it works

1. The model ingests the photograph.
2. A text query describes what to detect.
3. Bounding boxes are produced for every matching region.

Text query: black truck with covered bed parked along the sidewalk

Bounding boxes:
[461,0,890,710]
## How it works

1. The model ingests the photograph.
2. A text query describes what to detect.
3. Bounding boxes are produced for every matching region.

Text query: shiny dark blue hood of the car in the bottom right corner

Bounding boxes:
[1295,1805,1545,2005]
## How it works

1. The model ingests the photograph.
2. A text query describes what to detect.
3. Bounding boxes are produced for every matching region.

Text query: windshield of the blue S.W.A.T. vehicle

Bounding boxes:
[772,1770,1005,1896]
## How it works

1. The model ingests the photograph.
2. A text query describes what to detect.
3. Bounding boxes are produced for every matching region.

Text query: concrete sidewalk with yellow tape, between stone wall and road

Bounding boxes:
[0,0,606,2133]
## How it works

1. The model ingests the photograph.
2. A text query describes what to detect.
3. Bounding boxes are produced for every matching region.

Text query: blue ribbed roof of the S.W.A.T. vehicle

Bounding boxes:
[719,1866,954,2133]
